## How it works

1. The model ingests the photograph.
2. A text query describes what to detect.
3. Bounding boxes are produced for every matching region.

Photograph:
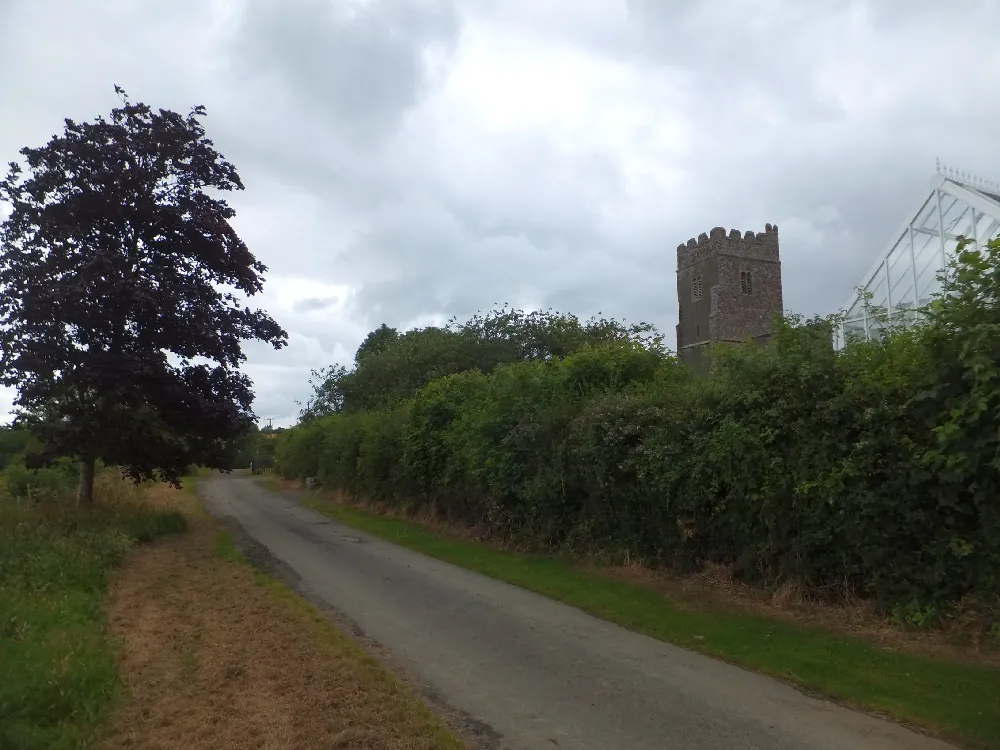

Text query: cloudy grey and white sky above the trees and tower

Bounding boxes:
[0,0,1000,425]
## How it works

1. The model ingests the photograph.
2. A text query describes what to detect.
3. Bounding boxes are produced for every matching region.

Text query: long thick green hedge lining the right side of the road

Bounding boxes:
[277,243,1000,622]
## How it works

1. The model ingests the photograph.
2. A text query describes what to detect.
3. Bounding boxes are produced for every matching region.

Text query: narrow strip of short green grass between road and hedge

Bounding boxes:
[280,488,1000,748]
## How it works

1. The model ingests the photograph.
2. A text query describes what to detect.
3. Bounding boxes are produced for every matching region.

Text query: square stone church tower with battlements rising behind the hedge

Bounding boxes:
[677,224,784,368]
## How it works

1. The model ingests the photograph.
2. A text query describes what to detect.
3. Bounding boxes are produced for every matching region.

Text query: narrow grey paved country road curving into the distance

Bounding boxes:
[199,475,950,750]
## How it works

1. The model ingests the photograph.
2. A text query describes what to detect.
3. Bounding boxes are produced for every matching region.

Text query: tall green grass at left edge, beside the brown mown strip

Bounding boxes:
[0,497,186,750]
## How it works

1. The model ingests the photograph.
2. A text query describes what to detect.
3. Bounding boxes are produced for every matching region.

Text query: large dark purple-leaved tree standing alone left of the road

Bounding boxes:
[0,86,287,504]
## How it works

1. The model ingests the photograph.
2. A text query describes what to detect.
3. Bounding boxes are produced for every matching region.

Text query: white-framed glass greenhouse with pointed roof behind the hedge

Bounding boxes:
[835,167,1000,349]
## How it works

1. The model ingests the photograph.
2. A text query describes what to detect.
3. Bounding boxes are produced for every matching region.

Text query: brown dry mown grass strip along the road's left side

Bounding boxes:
[105,487,459,750]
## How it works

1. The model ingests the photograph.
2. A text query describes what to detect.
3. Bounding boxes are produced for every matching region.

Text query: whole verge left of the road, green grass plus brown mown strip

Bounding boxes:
[0,458,462,750]
